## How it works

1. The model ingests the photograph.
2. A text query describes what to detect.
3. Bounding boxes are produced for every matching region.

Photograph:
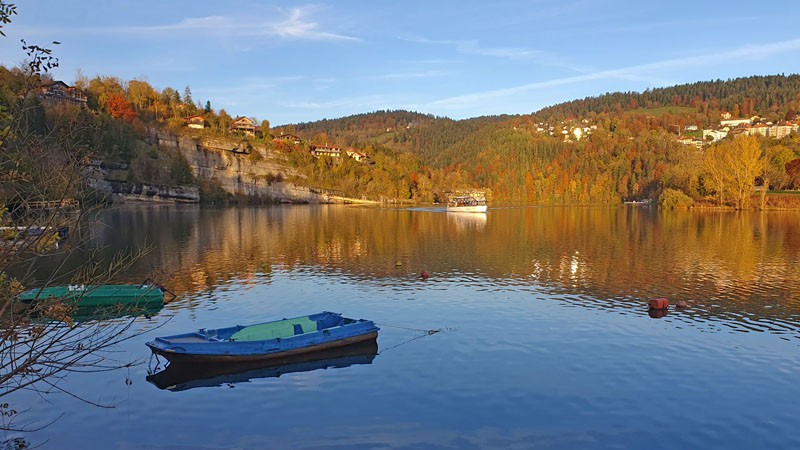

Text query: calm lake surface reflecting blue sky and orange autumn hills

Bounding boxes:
[9,206,800,449]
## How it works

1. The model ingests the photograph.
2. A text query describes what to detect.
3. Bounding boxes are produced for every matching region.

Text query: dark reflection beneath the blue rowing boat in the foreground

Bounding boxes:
[147,339,378,391]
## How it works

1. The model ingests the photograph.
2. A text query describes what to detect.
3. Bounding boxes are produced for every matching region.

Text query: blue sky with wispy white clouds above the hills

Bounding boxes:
[0,0,800,125]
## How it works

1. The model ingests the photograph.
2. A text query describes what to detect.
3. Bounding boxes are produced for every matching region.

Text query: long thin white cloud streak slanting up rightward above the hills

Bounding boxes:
[426,39,800,108]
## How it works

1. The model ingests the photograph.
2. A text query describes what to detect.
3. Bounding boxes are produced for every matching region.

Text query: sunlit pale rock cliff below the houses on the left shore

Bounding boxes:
[148,129,332,203]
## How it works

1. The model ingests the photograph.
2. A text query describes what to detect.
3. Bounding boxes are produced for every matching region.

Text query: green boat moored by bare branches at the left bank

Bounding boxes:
[17,284,164,308]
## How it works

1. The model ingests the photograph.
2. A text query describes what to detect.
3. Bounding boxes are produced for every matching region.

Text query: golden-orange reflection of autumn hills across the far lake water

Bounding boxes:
[90,206,800,334]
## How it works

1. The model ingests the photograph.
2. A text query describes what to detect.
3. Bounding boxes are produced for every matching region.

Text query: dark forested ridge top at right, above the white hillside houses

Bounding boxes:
[534,75,800,122]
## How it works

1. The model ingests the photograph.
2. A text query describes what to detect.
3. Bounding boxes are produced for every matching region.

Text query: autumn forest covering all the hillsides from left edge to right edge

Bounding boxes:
[0,58,800,208]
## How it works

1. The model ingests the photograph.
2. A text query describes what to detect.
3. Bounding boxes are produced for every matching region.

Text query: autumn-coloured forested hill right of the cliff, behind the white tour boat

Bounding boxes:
[276,75,800,204]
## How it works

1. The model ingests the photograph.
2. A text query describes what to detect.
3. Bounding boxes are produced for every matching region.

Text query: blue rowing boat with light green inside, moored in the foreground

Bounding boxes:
[147,311,379,363]
